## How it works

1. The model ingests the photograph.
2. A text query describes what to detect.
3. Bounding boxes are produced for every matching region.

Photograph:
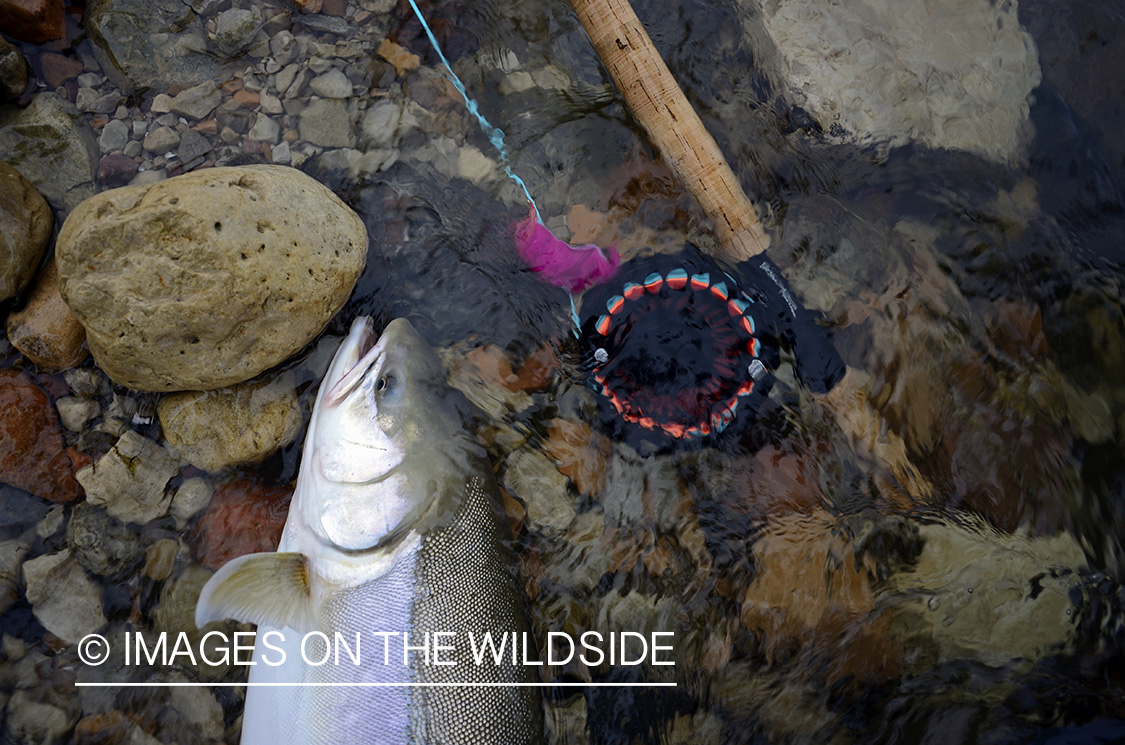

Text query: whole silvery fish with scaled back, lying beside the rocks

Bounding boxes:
[196,318,542,745]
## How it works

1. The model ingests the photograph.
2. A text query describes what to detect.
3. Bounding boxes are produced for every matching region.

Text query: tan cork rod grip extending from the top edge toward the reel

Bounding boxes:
[570,0,770,261]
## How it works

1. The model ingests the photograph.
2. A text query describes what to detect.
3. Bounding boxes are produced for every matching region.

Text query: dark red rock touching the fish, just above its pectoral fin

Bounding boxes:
[196,481,293,569]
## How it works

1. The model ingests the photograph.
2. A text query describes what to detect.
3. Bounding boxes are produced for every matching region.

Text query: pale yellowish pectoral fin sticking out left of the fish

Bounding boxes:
[196,551,315,631]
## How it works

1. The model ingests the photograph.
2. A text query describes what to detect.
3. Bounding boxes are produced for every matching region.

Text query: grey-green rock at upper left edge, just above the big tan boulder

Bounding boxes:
[0,92,99,213]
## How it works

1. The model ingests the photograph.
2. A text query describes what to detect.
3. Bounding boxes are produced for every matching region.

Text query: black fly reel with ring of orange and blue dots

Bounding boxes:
[578,244,844,450]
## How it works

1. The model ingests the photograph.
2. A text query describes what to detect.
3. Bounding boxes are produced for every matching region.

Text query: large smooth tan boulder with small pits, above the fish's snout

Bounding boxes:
[56,165,367,391]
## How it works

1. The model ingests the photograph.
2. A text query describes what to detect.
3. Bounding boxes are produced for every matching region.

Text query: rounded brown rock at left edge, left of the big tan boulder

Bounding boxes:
[0,161,54,302]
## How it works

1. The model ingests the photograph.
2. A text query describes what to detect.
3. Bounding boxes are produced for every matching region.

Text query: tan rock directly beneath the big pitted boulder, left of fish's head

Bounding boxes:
[156,373,302,473]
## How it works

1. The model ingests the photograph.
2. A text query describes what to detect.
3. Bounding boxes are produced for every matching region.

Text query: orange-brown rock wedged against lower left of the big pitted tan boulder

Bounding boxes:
[8,257,90,370]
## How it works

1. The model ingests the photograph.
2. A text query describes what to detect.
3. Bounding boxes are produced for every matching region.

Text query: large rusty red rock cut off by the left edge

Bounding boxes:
[0,369,82,503]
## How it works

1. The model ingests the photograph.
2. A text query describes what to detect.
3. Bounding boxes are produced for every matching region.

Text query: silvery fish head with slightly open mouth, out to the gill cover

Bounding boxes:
[296,317,466,550]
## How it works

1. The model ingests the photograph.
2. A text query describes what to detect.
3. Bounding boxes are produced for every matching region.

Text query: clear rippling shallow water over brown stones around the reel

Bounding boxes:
[6,2,1125,743]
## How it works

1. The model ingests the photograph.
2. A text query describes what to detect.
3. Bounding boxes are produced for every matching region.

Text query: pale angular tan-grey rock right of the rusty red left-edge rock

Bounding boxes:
[78,430,180,523]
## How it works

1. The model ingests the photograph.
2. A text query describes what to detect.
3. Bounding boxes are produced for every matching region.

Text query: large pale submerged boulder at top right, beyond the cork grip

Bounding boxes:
[748,0,1041,160]
